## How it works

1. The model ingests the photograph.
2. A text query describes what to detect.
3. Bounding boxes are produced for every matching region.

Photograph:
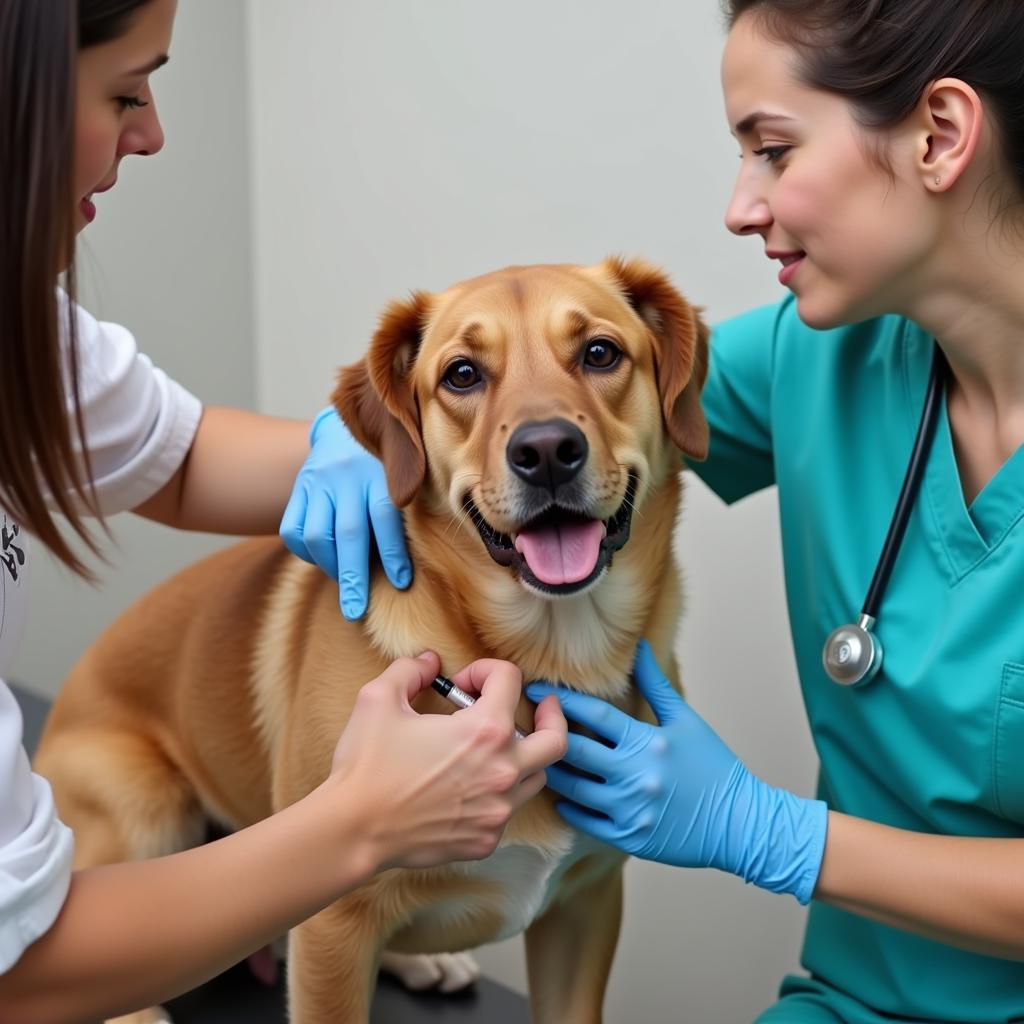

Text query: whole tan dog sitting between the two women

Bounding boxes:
[37,260,708,1024]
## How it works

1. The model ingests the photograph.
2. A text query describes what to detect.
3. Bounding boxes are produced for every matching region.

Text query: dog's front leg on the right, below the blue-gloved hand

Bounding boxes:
[526,866,623,1024]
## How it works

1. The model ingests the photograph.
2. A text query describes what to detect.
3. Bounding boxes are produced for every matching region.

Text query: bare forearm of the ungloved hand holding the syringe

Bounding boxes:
[0,780,376,1024]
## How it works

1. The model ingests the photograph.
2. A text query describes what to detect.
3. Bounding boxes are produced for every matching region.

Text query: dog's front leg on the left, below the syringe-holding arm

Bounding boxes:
[288,898,382,1024]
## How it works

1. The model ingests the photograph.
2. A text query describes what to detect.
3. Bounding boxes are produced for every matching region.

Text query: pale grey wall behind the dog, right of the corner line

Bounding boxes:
[249,0,814,1024]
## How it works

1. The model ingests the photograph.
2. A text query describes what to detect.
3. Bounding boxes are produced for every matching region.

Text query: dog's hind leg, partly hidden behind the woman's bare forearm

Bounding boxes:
[34,729,205,1024]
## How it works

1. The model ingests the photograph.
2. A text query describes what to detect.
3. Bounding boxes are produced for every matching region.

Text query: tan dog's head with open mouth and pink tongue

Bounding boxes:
[334,259,708,596]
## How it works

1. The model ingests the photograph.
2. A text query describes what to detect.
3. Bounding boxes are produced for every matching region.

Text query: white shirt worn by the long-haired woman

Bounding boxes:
[0,294,202,974]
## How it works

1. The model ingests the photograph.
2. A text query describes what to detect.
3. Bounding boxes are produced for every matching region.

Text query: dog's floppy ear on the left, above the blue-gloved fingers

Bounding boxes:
[331,292,430,508]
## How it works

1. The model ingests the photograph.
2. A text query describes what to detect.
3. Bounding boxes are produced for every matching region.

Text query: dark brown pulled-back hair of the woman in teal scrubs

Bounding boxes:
[722,0,1024,203]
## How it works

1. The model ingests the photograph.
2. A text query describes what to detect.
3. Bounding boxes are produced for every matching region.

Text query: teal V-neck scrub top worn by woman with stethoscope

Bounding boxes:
[692,297,1024,1022]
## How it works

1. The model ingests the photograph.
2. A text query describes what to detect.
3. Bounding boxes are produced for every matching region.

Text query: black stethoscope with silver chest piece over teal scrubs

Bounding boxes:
[821,345,946,686]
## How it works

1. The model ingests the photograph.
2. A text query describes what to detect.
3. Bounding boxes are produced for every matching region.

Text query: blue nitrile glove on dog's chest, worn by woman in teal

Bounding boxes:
[526,641,827,903]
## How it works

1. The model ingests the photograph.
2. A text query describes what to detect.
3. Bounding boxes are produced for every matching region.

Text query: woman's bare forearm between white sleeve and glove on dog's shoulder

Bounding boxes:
[135,407,309,535]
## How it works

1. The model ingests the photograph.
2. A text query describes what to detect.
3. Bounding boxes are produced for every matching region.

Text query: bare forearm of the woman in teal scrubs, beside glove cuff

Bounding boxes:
[814,811,1024,959]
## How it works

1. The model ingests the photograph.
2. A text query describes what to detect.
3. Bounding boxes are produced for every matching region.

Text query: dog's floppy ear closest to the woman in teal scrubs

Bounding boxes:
[604,257,709,459]
